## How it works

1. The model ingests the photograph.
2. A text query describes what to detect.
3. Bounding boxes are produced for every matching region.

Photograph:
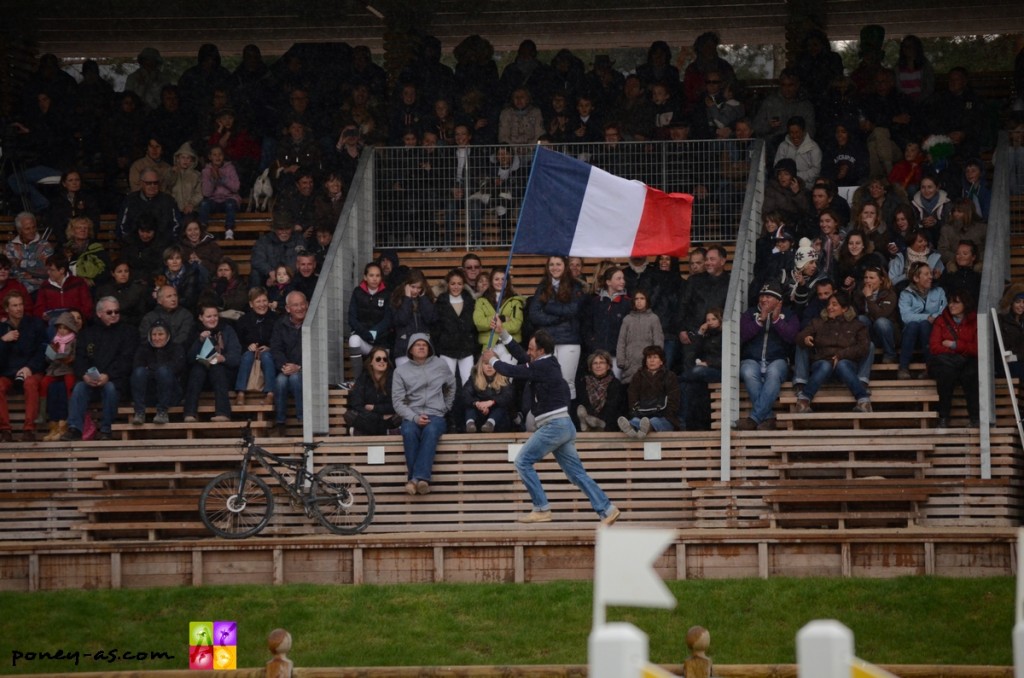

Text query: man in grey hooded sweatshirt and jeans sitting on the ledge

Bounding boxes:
[391,333,456,495]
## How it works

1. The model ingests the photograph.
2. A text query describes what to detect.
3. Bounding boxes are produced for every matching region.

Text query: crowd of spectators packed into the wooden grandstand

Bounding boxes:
[0,27,1024,440]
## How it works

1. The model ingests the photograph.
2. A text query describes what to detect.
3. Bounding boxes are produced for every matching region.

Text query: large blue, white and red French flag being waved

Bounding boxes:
[512,146,693,257]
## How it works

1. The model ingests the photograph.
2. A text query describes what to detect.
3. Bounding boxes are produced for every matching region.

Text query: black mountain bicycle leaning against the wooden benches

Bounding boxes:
[199,424,376,539]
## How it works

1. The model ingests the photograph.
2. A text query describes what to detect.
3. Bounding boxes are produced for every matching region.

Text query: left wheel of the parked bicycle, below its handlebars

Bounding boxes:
[199,471,273,539]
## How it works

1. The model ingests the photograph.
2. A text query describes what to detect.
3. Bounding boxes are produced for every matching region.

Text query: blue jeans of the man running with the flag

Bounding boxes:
[515,417,611,517]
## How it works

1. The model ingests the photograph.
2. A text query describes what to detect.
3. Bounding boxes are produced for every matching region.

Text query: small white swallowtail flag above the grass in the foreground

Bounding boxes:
[594,527,676,628]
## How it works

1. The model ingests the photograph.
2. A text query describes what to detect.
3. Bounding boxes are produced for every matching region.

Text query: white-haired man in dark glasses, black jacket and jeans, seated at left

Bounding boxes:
[60,297,136,441]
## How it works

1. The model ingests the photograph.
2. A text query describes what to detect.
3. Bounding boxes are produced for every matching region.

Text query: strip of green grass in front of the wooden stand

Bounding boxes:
[0,577,1014,673]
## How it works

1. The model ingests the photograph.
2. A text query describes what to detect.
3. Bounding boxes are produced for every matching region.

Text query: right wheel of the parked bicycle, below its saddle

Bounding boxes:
[312,464,377,535]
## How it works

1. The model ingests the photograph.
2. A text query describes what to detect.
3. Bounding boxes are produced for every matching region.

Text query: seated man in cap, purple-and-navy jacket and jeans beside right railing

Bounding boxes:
[736,281,800,431]
